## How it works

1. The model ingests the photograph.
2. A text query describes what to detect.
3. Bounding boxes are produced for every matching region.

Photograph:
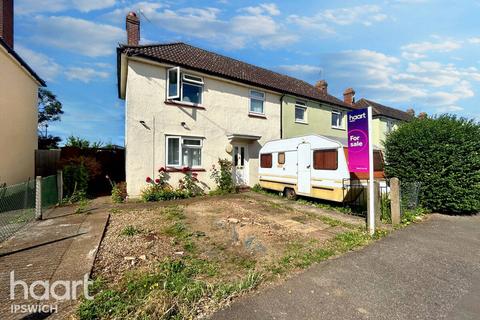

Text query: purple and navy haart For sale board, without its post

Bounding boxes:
[347,109,370,172]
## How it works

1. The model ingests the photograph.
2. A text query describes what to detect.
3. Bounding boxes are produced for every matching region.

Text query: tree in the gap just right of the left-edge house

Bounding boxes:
[38,88,63,149]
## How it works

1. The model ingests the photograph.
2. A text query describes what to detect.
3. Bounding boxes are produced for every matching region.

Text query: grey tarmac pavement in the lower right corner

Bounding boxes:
[213,215,480,320]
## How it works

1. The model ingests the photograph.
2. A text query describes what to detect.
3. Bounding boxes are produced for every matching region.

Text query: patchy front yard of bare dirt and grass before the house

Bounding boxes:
[77,193,386,319]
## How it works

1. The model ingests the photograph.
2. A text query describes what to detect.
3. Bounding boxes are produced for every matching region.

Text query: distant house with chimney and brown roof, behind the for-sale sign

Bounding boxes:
[343,88,413,149]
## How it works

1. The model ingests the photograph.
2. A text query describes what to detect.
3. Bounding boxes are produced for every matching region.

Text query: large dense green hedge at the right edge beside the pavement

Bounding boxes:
[385,115,480,213]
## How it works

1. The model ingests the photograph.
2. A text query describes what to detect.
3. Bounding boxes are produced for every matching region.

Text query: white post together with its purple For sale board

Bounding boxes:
[348,107,375,234]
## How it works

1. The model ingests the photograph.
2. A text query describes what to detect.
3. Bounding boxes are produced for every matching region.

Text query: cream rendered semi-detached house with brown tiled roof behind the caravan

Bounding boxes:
[117,12,351,197]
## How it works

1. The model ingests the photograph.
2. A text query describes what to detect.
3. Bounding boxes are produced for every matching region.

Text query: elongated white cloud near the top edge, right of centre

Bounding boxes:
[288,5,388,33]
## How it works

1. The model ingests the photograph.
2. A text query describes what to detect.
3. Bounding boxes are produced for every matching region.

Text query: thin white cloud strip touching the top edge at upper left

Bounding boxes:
[15,0,116,15]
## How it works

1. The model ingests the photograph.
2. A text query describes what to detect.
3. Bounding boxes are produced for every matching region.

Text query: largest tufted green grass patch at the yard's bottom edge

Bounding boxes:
[77,259,262,319]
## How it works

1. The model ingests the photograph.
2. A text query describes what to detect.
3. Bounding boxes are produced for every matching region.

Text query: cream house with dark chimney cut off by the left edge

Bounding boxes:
[0,0,45,185]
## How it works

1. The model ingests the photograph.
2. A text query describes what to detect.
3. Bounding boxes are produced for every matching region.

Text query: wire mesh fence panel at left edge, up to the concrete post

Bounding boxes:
[0,180,35,242]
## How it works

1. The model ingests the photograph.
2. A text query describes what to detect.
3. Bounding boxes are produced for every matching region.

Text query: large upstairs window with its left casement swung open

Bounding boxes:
[167,67,204,104]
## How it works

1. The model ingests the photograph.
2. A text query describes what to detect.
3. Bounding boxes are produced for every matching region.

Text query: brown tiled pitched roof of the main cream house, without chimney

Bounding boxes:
[117,42,352,109]
